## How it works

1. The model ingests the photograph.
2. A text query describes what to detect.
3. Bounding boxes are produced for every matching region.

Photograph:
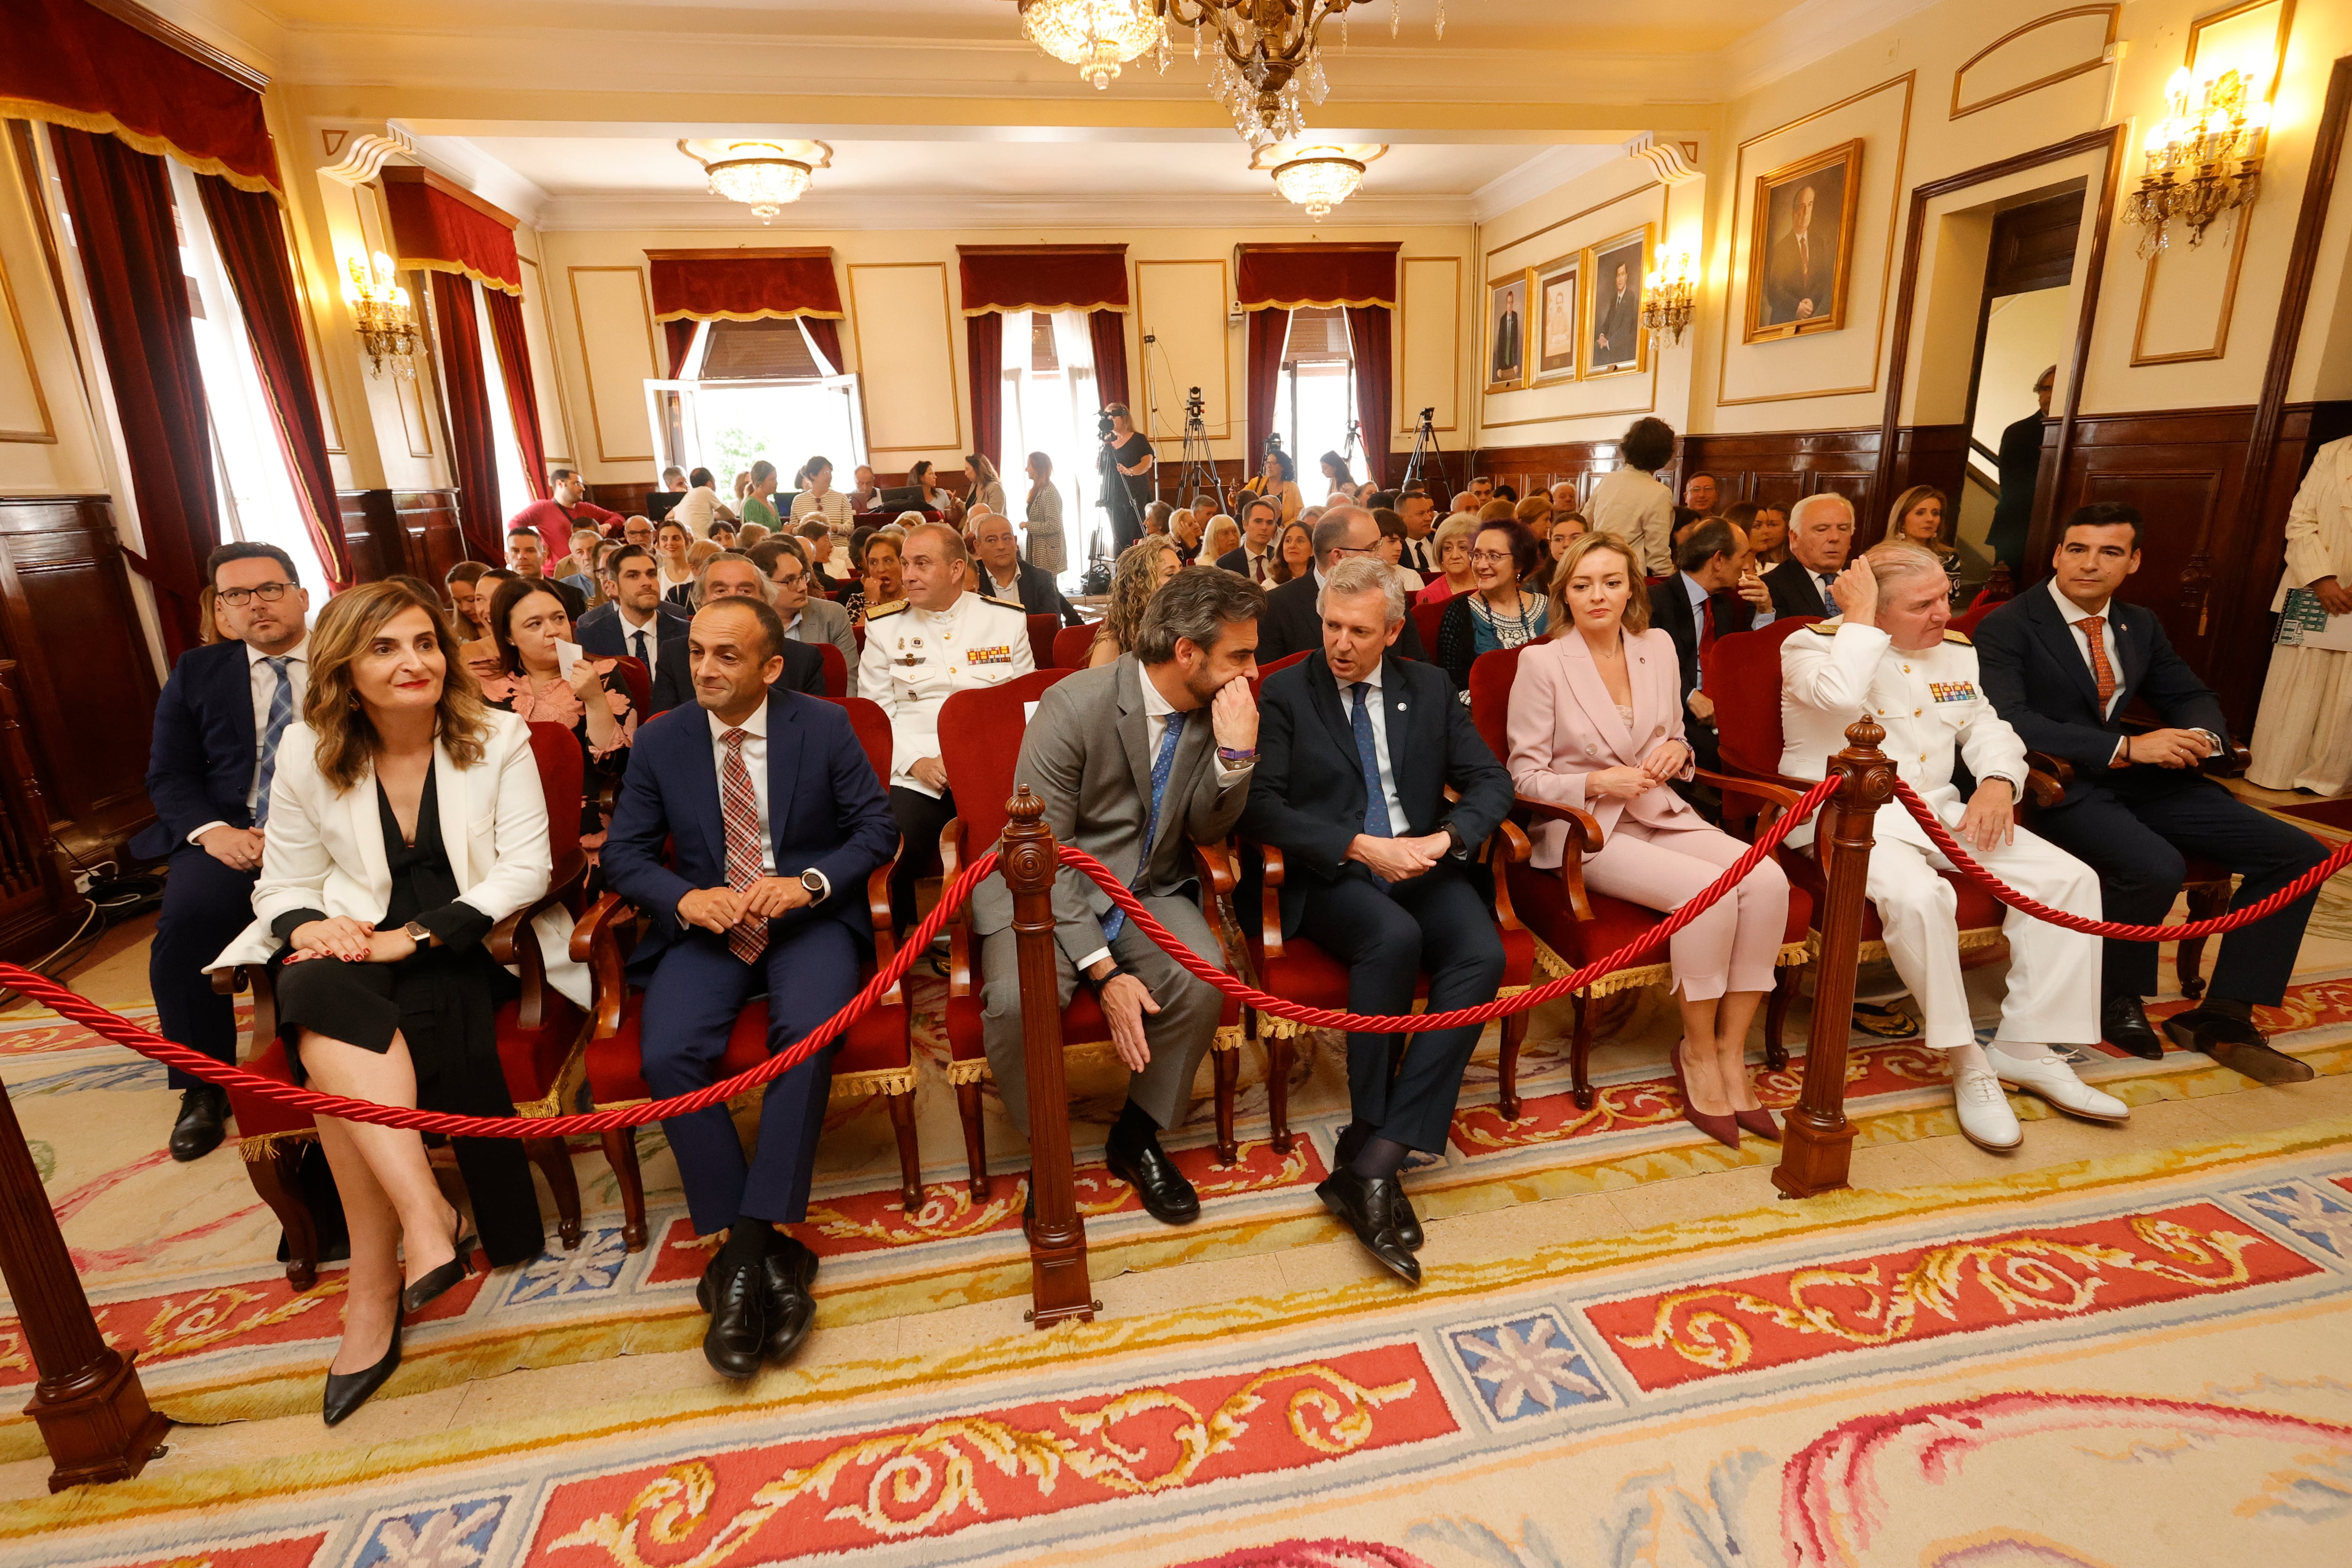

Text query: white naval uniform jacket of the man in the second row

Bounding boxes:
[858,588,1037,797]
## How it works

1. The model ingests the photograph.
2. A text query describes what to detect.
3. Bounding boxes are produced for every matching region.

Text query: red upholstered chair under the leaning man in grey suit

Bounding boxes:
[938,670,1251,1199]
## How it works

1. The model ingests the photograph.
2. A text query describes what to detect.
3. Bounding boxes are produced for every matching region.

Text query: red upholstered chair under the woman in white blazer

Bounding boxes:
[214,719,593,1290]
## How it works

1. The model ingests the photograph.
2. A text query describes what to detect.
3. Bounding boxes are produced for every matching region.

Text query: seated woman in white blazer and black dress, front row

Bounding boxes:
[214,581,586,1425]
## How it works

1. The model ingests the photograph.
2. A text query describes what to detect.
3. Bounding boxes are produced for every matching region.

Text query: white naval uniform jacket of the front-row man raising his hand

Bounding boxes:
[1780,616,2025,849]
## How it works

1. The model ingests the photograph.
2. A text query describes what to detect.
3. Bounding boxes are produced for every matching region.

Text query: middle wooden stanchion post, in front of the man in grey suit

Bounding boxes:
[997,785,1096,1328]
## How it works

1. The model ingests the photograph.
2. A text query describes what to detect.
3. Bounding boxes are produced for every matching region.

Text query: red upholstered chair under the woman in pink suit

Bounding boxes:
[1470,644,1813,1117]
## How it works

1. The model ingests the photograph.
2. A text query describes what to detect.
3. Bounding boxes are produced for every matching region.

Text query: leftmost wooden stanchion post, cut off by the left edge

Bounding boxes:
[0,1072,172,1493]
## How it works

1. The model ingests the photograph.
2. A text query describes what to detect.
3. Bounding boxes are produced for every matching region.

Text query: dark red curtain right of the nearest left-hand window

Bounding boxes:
[195,174,350,588]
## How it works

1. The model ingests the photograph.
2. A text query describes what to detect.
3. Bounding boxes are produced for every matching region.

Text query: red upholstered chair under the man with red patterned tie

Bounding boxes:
[572,700,922,1250]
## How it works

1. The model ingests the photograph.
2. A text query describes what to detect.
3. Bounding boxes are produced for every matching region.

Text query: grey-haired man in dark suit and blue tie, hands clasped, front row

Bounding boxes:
[1242,557,1512,1283]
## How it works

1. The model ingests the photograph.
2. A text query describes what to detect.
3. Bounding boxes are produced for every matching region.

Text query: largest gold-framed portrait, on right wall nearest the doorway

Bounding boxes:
[1740,136,1863,343]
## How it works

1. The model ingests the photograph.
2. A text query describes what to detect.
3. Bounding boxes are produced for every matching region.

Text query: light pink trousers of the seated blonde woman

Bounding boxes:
[1585,816,1788,1002]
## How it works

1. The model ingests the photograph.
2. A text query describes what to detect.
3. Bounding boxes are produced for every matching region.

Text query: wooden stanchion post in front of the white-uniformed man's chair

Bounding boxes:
[1771,719,1896,1199]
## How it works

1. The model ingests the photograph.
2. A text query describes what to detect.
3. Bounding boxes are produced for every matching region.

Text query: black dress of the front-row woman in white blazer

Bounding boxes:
[270,771,546,1265]
